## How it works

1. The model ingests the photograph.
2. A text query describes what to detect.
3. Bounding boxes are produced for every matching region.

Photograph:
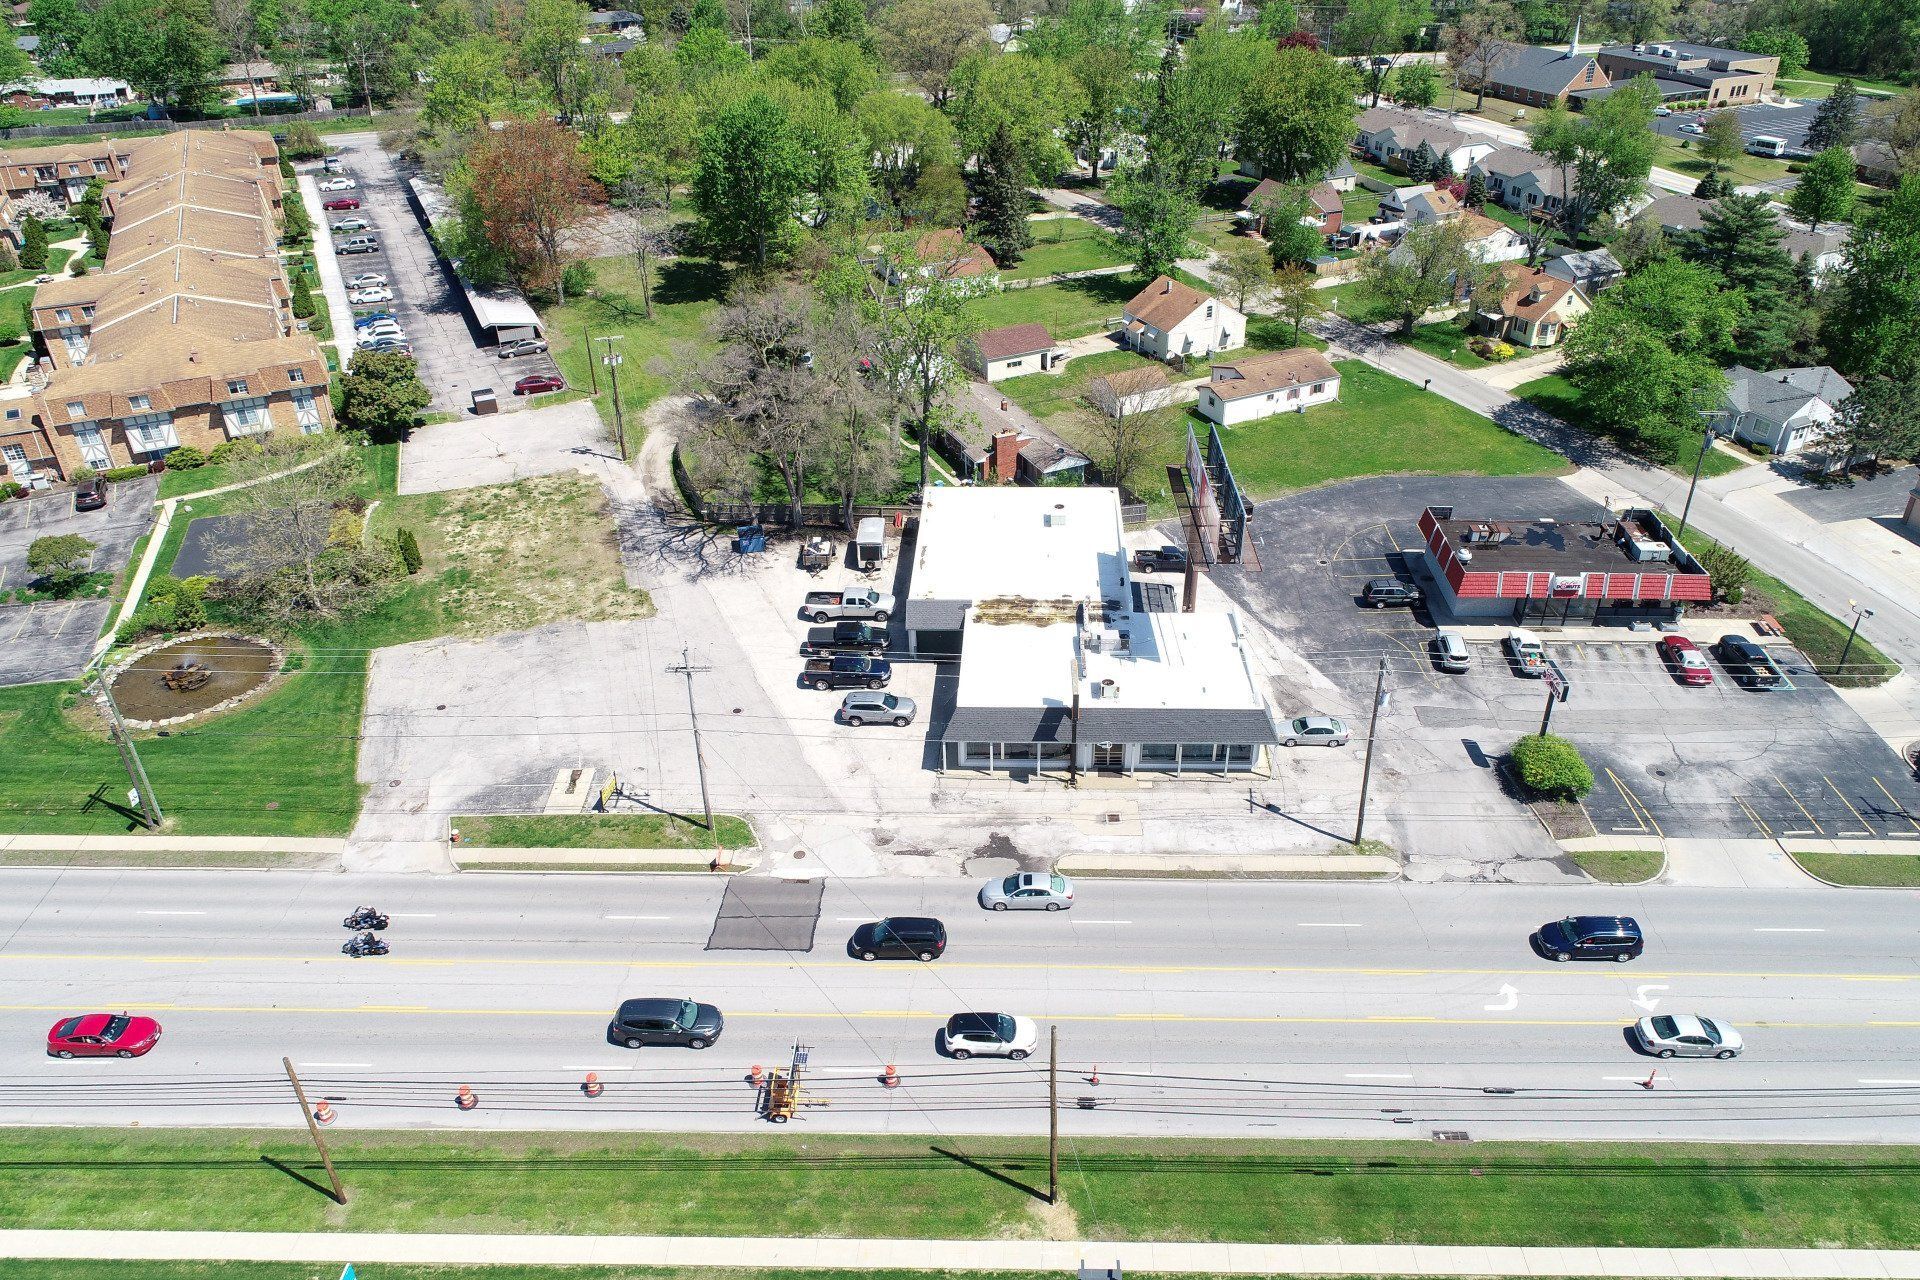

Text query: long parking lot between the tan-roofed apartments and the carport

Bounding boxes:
[313,134,559,413]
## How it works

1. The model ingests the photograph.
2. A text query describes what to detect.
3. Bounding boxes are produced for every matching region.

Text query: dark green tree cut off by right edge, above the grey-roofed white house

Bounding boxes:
[1820,177,1920,382]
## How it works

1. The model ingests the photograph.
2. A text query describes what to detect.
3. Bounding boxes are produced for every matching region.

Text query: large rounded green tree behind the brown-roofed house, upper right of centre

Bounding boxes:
[1236,48,1359,182]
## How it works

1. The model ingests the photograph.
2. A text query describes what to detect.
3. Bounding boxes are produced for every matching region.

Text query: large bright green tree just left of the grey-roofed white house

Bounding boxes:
[1565,259,1745,462]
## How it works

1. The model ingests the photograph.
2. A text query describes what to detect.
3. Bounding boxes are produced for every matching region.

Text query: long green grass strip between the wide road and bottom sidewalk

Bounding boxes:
[11,1136,1920,1247]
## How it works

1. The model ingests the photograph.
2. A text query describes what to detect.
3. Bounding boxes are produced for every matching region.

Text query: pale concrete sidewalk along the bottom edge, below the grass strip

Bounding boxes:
[0,1230,1920,1280]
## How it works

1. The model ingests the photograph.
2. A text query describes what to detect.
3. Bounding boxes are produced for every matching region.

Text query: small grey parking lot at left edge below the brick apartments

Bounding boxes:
[0,476,159,685]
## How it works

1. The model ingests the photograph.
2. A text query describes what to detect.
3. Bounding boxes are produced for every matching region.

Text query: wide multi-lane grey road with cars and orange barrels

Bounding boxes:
[0,869,1920,1142]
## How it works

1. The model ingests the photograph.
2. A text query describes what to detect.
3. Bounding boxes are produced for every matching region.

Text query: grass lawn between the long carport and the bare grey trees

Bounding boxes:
[541,255,730,451]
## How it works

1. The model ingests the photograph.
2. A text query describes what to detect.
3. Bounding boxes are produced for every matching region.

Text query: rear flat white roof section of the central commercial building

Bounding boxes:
[908,486,1129,614]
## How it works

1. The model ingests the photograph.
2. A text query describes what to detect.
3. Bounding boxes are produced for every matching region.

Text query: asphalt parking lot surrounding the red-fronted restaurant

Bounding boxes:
[1215,478,1920,858]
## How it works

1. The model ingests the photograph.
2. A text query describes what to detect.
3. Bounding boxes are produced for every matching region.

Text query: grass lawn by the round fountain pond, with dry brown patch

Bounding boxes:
[0,445,651,835]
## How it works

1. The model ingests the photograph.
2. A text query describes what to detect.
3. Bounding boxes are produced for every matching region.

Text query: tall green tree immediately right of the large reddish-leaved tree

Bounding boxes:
[693,90,810,269]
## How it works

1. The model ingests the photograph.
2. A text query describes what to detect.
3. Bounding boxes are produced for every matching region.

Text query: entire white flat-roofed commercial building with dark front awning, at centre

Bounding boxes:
[904,486,1279,773]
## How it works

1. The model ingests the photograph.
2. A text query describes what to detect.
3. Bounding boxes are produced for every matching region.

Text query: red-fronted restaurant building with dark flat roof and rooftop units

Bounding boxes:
[1421,507,1713,628]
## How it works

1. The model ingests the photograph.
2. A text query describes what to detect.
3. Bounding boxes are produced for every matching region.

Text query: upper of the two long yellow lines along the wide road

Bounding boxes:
[0,952,1920,983]
